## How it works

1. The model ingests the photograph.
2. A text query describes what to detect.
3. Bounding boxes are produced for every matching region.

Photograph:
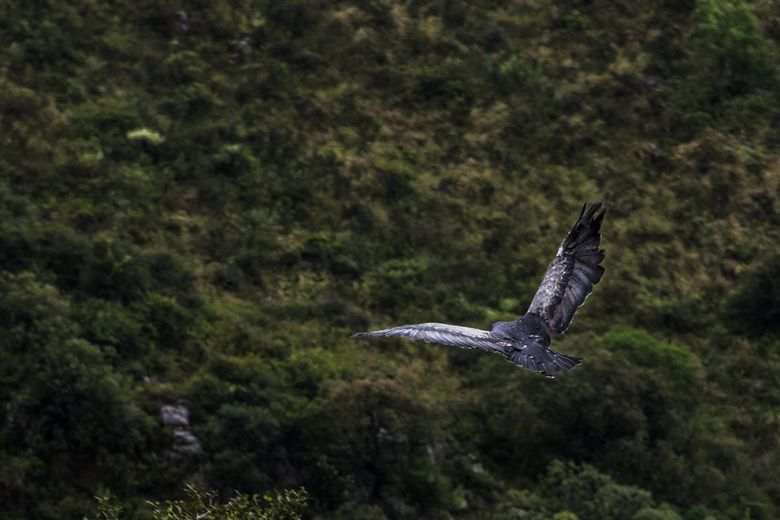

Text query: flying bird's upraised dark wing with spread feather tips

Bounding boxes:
[528,202,604,334]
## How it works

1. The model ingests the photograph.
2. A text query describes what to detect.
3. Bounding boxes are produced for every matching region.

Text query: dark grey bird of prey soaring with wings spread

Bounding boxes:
[352,202,605,377]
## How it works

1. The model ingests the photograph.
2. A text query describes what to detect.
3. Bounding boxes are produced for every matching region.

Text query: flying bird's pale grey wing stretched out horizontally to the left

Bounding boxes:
[352,323,511,353]
